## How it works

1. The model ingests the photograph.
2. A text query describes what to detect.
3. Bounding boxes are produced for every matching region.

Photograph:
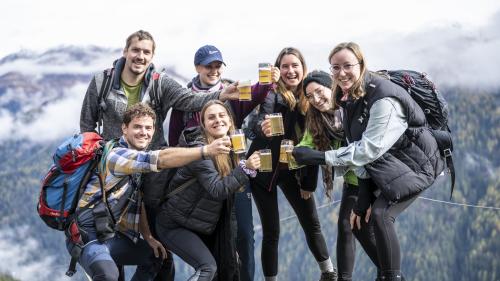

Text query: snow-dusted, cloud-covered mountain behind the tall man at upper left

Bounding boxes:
[0,46,186,142]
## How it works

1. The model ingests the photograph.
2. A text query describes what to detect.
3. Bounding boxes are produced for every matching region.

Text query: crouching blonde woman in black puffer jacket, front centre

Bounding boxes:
[156,101,260,281]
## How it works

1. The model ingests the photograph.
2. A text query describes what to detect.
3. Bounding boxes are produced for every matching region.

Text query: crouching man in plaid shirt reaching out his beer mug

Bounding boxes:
[67,103,230,281]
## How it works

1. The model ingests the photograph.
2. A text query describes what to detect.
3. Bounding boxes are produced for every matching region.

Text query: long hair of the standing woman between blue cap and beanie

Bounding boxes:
[274,47,309,115]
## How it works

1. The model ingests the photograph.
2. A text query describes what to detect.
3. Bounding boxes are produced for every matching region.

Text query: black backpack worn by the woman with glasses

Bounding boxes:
[377,70,455,197]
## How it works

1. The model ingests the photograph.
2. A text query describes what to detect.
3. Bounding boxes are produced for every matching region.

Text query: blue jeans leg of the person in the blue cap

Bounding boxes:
[234,184,255,281]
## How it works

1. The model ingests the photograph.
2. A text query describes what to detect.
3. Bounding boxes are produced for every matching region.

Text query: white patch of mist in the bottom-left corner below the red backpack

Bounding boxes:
[0,226,74,281]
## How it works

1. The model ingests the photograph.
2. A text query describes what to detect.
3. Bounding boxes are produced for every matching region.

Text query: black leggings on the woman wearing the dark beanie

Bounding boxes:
[337,183,379,280]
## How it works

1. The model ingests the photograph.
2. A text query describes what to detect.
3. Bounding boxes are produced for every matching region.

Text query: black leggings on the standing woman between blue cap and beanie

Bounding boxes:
[251,170,329,276]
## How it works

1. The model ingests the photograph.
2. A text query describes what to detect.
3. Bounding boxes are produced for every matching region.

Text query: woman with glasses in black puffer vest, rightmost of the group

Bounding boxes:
[293,42,444,281]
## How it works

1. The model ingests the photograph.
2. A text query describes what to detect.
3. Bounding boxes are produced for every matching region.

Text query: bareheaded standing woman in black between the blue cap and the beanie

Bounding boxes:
[248,48,336,281]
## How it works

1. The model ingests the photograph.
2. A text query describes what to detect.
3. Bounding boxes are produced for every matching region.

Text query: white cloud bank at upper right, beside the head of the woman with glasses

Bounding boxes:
[362,10,500,88]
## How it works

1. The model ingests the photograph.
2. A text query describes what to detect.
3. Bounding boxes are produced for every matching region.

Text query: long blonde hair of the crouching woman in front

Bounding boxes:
[200,100,236,177]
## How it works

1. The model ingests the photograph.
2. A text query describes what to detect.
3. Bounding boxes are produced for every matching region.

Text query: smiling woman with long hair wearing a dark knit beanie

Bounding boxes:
[299,70,378,281]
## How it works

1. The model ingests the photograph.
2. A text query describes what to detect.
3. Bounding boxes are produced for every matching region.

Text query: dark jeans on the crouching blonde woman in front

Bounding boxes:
[156,215,217,281]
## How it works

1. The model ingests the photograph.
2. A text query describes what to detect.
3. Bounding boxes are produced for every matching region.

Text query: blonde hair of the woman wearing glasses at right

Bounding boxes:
[328,42,367,108]
